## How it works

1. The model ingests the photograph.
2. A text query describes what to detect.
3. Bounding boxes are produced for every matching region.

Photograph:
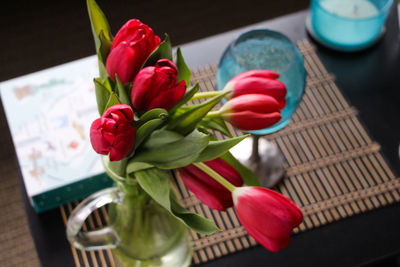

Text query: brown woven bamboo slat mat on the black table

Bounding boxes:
[60,41,400,266]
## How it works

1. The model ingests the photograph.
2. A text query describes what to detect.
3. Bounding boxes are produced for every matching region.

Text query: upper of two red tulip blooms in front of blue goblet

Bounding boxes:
[226,70,287,108]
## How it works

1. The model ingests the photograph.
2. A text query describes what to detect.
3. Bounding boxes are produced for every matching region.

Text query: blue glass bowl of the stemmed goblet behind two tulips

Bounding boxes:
[216,29,306,135]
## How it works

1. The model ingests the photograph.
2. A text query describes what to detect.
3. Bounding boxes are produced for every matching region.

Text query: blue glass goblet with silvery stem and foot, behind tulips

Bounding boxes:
[216,29,306,187]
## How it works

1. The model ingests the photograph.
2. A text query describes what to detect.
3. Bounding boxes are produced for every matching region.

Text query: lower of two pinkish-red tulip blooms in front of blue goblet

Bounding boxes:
[220,94,282,131]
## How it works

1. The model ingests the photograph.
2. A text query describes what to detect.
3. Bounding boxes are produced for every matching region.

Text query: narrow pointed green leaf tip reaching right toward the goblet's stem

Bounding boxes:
[196,135,249,162]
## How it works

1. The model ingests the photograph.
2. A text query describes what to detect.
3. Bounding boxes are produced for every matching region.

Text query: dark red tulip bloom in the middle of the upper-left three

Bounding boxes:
[131,59,186,111]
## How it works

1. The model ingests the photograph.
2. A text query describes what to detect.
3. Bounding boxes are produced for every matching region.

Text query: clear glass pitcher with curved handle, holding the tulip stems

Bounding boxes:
[67,158,192,267]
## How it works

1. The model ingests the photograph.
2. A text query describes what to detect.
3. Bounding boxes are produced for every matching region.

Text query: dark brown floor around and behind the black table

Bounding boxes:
[0,0,309,266]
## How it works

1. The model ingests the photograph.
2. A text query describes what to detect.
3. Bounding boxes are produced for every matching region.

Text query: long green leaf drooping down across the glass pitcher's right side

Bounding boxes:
[135,168,221,234]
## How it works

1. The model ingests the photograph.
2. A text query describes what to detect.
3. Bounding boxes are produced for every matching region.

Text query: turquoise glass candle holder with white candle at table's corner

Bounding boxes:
[311,0,393,51]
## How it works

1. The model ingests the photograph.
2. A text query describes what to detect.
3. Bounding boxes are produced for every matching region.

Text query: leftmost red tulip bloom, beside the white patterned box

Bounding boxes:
[90,104,136,161]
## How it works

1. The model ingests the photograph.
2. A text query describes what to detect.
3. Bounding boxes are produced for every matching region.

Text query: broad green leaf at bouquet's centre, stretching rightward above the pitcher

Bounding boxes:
[133,130,209,169]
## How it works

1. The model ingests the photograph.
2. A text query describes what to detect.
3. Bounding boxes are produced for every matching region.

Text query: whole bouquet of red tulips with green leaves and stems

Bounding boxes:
[88,0,302,251]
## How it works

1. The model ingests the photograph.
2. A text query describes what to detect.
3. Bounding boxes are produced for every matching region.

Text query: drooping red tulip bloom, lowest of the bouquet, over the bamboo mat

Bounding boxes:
[233,187,303,252]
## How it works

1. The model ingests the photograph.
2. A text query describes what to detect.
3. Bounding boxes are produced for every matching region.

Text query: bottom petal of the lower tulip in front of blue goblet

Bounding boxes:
[222,111,282,131]
